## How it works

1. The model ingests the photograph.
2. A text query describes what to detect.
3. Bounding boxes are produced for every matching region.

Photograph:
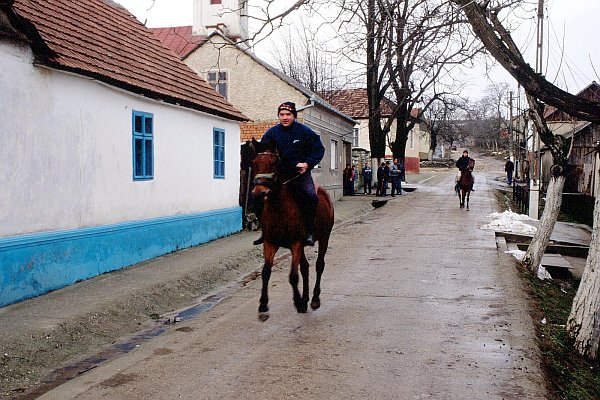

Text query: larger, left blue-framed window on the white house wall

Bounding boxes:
[132,111,154,180]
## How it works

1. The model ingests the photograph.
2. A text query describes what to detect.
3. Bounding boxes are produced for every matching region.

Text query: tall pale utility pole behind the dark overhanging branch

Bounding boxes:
[529,0,544,219]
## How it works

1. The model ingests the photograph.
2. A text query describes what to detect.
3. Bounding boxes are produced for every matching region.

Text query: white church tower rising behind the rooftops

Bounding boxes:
[192,0,248,42]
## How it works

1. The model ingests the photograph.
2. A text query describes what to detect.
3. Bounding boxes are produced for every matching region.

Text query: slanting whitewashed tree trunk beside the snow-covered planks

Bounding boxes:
[523,175,565,275]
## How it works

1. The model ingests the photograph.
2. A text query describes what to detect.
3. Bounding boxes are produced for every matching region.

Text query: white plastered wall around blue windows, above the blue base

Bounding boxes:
[0,41,240,237]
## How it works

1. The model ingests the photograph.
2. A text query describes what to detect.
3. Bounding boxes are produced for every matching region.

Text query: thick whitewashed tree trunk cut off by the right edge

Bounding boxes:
[567,162,600,360]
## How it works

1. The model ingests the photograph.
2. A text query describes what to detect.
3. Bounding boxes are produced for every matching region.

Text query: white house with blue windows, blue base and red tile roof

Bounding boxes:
[0,0,247,307]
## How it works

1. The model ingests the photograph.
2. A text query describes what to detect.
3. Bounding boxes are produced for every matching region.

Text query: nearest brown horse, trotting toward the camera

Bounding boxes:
[252,140,334,321]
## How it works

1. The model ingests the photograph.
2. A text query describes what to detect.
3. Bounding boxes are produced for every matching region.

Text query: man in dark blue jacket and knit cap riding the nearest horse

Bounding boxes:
[254,101,325,246]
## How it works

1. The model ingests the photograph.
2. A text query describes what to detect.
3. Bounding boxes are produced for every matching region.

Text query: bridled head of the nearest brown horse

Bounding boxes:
[251,138,279,198]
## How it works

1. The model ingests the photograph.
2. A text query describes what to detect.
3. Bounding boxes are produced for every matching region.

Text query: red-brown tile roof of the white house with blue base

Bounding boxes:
[7,0,247,121]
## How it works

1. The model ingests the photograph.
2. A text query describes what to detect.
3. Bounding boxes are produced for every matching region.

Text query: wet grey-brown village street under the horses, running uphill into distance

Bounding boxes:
[31,159,546,400]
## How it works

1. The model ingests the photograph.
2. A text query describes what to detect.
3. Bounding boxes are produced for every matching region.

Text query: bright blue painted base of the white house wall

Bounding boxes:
[0,207,242,307]
